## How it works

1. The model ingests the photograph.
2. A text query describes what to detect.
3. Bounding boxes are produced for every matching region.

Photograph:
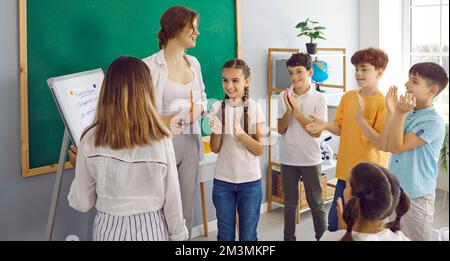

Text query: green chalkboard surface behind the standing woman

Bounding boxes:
[26,0,238,174]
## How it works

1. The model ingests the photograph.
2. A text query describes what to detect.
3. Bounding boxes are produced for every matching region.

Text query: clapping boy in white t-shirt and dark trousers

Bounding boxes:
[278,53,327,241]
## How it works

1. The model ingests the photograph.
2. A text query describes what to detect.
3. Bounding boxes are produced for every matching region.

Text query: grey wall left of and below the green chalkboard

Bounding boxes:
[0,0,95,240]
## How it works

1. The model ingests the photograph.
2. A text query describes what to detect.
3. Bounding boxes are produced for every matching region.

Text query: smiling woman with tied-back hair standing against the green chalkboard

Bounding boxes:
[143,6,207,238]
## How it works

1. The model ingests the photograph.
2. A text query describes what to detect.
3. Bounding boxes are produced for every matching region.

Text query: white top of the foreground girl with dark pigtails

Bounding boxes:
[320,228,410,241]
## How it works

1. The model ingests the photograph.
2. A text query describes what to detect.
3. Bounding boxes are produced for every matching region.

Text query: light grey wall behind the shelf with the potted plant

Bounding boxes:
[241,0,360,201]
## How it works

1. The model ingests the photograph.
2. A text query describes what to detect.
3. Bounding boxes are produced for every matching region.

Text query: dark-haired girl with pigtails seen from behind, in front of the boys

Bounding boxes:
[322,162,410,241]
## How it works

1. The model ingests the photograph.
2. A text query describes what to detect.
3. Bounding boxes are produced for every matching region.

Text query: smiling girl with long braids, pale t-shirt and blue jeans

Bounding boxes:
[210,59,265,241]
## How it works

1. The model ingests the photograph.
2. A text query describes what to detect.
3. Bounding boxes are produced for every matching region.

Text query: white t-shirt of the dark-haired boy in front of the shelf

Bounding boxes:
[278,86,327,166]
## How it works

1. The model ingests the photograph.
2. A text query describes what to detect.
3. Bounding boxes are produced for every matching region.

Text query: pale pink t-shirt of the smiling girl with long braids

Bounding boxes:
[210,99,265,184]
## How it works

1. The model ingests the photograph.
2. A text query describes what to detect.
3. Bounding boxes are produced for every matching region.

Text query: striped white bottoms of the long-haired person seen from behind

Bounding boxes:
[92,209,169,241]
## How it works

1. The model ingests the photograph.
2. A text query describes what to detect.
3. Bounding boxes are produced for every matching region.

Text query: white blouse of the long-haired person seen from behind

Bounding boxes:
[68,128,188,240]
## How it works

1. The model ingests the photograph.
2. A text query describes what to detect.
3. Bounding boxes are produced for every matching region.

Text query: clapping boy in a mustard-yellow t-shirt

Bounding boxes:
[306,48,388,231]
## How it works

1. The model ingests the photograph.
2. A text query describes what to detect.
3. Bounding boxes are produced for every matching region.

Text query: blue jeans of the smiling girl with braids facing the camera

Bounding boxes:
[213,179,262,241]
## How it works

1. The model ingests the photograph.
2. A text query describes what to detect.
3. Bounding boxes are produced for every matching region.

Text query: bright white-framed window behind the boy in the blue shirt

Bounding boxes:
[404,0,449,122]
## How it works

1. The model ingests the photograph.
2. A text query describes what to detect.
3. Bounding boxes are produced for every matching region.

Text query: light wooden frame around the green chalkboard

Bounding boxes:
[19,0,242,177]
